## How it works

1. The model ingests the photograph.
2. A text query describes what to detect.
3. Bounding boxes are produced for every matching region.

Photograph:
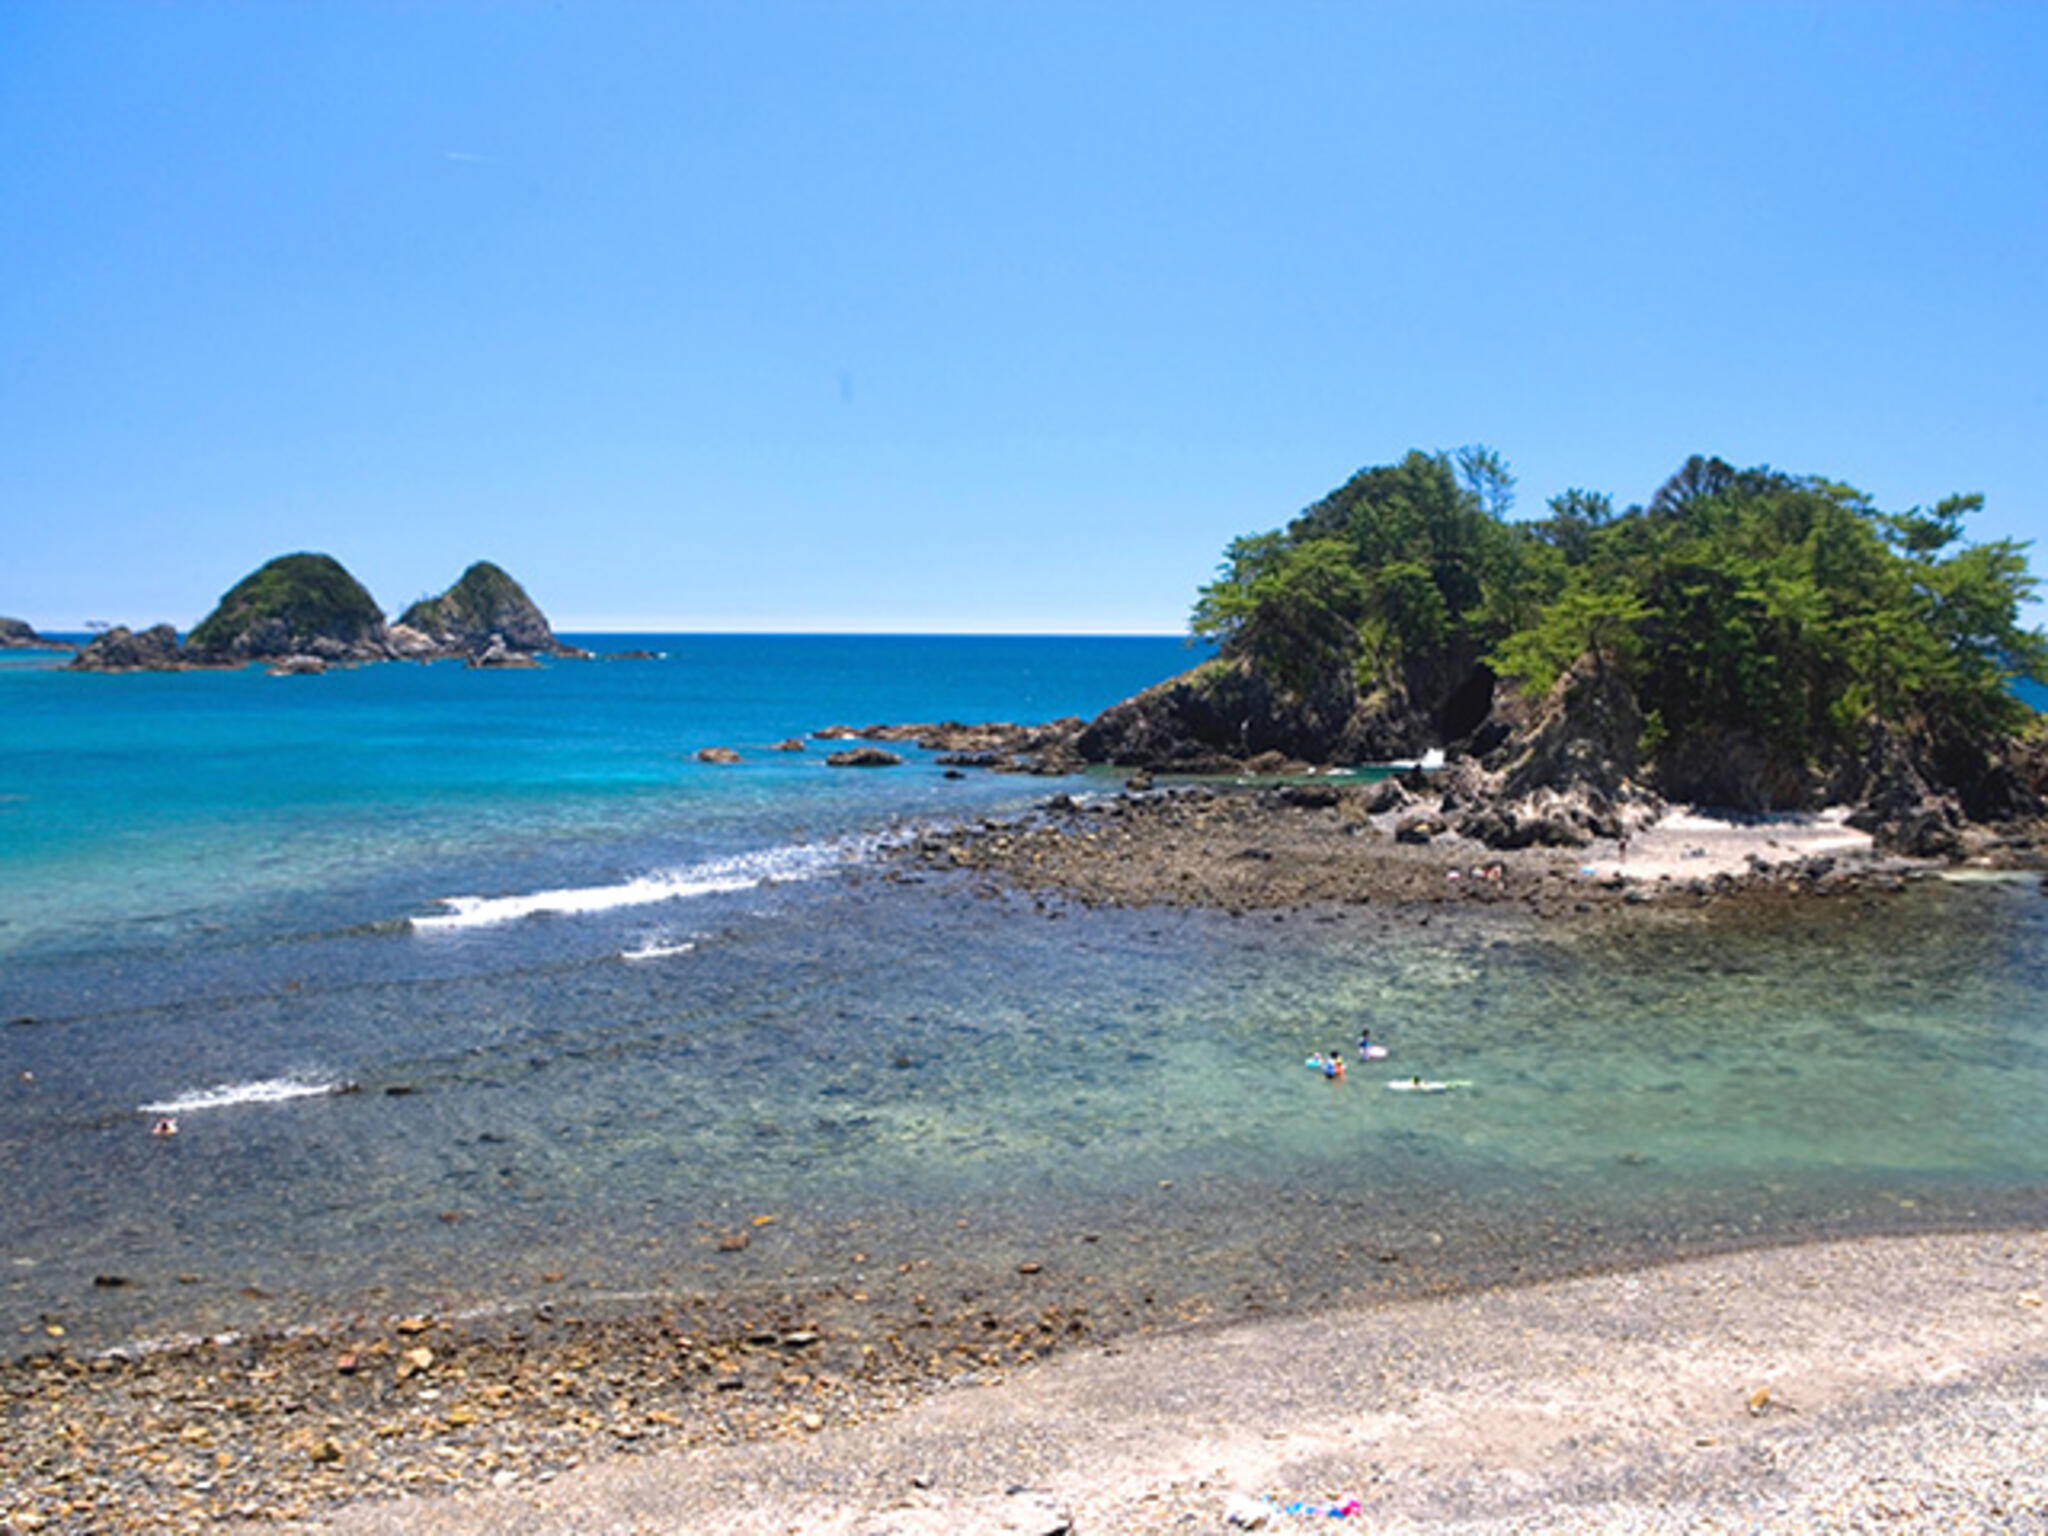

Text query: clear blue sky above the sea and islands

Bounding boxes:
[0,0,2048,633]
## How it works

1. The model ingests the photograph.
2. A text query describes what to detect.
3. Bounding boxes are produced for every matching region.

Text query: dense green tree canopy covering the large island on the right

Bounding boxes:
[1194,449,2048,794]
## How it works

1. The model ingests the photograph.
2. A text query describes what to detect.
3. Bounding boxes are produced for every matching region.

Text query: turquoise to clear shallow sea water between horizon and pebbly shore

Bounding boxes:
[0,635,2048,1348]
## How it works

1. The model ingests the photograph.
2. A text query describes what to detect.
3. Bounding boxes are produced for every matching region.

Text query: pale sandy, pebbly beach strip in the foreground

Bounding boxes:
[319,1228,2048,1536]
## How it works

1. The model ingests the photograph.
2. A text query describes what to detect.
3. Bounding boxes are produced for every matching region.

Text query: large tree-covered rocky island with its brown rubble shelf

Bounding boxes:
[888,449,2048,909]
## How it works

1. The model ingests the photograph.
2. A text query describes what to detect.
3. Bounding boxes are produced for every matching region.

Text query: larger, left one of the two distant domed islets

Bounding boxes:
[186,555,393,666]
